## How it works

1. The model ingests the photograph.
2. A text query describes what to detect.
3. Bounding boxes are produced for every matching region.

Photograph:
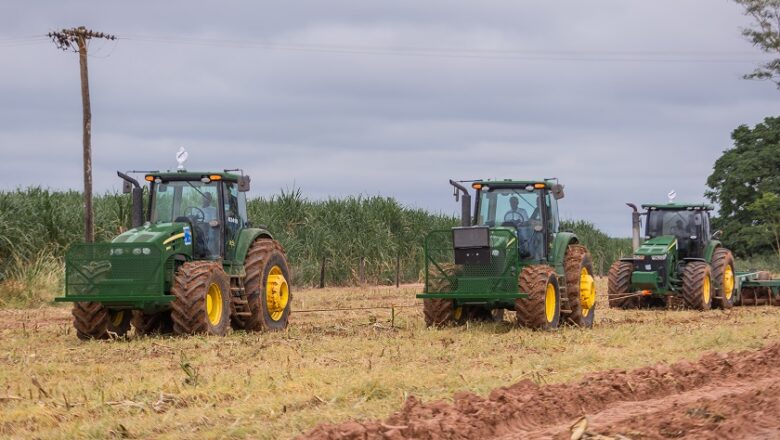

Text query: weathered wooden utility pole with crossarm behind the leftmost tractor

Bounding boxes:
[47,26,116,243]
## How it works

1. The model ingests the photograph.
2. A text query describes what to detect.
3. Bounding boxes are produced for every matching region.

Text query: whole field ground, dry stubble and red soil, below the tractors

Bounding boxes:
[0,279,780,440]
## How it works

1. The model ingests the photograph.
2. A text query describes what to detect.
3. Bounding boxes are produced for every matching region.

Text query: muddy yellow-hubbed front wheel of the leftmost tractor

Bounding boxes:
[171,261,230,336]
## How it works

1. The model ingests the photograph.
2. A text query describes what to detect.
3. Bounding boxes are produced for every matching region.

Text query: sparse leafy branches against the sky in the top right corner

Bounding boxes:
[734,0,780,89]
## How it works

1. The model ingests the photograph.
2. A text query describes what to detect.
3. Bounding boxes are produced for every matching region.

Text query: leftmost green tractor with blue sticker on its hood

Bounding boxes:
[56,160,292,339]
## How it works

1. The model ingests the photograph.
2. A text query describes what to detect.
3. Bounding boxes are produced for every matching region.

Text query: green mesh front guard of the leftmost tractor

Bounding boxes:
[65,243,163,296]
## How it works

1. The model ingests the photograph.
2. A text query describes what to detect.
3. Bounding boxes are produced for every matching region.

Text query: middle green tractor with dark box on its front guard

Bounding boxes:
[417,179,596,330]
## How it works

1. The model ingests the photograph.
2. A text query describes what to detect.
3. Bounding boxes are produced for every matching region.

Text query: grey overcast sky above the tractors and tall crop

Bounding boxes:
[0,0,780,236]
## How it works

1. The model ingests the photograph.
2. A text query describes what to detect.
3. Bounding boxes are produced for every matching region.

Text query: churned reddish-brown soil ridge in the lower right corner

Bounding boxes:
[304,343,780,440]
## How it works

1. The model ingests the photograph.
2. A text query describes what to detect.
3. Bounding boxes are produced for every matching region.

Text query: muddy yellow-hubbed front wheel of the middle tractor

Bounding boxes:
[515,264,561,330]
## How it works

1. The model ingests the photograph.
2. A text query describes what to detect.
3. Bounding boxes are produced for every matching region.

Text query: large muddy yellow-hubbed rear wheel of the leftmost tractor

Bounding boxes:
[238,238,292,331]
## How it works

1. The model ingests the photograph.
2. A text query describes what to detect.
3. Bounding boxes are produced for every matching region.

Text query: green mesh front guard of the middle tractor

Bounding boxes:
[425,229,519,296]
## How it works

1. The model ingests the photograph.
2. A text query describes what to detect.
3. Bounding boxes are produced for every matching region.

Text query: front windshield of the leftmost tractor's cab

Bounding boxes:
[151,181,218,223]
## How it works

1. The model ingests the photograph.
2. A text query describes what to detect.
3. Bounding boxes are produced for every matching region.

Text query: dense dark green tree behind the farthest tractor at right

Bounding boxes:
[705,117,780,256]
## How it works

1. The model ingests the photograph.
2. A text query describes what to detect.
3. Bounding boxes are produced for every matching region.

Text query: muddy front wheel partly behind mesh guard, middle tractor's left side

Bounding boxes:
[423,263,460,327]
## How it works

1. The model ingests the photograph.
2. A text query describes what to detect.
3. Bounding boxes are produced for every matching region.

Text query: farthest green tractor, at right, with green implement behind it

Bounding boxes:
[608,199,780,310]
